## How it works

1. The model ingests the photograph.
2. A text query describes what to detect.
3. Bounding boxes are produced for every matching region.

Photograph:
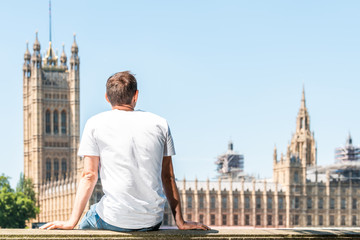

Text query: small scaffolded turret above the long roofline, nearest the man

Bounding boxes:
[215,141,244,179]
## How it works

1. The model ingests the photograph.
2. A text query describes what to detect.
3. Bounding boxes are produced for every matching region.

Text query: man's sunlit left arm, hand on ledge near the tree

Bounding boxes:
[40,156,100,229]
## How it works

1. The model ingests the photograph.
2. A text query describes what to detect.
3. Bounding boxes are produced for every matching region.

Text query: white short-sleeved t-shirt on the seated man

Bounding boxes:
[78,109,175,229]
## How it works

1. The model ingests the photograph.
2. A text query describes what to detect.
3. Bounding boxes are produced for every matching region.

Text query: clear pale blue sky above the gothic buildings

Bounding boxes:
[0,0,360,188]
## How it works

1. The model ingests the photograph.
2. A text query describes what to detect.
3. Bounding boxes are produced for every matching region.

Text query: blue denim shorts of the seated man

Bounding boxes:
[79,204,161,232]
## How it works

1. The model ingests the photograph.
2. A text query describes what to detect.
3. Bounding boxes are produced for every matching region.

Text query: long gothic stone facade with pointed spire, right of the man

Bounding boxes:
[163,91,360,228]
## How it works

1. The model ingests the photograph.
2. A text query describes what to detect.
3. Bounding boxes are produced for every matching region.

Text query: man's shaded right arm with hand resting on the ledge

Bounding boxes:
[161,157,210,230]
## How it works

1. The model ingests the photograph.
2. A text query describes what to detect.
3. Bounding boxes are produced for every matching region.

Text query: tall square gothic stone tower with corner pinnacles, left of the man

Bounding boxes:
[23,33,80,222]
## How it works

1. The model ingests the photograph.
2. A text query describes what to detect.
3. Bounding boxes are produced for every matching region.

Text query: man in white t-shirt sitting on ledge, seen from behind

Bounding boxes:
[41,72,210,232]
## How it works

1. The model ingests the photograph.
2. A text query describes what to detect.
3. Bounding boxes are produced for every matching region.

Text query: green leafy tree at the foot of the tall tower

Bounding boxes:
[0,174,39,228]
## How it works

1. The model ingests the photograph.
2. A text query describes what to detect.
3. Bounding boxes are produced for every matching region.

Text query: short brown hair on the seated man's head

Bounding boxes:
[106,71,137,106]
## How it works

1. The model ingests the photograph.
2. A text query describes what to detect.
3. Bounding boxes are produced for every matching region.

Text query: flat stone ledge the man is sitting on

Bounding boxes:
[0,228,360,240]
